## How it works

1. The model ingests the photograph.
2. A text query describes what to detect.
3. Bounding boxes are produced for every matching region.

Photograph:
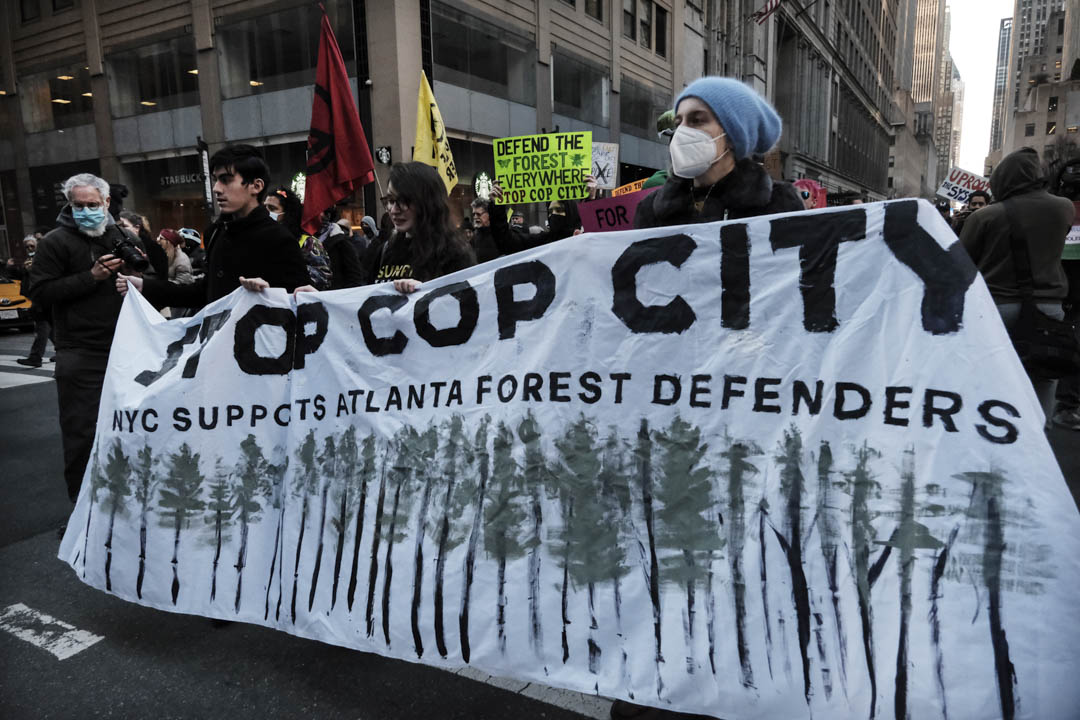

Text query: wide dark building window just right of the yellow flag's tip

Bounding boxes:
[431,2,537,106]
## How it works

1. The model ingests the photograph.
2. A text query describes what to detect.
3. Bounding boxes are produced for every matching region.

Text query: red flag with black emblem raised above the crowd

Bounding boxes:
[301,12,375,234]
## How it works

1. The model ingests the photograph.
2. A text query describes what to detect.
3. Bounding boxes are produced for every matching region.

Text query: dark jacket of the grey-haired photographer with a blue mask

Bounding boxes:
[27,205,143,353]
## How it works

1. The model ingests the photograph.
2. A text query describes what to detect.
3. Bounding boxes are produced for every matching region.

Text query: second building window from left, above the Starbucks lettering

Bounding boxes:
[105,35,199,118]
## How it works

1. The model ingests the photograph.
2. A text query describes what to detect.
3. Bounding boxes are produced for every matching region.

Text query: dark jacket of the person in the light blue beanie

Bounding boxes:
[634,158,804,228]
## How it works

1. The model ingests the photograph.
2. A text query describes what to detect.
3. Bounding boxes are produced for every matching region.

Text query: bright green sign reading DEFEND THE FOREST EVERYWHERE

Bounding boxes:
[492,133,593,205]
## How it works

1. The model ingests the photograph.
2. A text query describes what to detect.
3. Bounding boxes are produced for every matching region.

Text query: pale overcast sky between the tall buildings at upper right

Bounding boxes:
[948,0,1013,173]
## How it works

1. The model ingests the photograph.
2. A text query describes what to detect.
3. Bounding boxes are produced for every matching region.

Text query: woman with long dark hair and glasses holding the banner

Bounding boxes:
[367,162,476,293]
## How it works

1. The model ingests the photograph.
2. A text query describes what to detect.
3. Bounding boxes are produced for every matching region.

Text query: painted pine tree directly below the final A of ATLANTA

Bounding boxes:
[424,415,472,657]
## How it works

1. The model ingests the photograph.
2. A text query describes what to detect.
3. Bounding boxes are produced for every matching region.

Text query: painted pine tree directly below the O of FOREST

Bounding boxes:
[484,422,525,654]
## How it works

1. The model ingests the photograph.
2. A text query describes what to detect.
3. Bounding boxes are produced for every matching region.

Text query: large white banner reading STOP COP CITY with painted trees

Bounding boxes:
[59,201,1080,720]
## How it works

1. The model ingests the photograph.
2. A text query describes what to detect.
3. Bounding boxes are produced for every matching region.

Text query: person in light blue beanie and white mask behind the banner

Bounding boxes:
[634,77,804,228]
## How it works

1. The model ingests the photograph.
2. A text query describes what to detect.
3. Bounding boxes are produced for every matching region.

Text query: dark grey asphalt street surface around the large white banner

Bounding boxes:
[0,331,1080,720]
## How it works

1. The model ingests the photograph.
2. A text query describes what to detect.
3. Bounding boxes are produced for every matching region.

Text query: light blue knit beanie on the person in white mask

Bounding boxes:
[675,77,783,160]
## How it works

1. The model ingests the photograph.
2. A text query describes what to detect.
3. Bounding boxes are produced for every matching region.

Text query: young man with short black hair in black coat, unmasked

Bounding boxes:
[117,145,308,309]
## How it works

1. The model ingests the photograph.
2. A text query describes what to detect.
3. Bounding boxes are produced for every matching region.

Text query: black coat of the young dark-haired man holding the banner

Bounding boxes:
[143,205,308,308]
